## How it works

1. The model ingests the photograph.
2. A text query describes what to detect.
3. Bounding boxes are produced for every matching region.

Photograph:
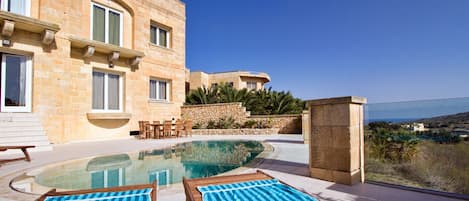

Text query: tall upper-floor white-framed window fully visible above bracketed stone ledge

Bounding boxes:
[91,3,123,46]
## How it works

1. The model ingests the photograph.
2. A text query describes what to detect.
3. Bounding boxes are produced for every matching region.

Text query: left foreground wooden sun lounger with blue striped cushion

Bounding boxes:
[36,180,157,201]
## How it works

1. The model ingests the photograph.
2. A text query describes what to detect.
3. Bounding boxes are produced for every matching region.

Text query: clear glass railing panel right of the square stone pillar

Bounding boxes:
[365,98,469,198]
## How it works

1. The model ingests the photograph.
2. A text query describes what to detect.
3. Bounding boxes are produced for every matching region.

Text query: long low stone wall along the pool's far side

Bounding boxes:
[192,128,279,135]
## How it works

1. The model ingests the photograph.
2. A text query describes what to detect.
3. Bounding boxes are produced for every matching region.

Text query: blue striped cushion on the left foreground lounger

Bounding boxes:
[45,188,153,201]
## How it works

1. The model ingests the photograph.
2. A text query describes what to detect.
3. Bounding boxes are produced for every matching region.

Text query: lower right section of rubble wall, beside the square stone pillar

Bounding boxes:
[248,114,302,134]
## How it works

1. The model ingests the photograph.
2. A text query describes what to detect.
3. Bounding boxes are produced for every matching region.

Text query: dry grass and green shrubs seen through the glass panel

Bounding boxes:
[365,122,469,194]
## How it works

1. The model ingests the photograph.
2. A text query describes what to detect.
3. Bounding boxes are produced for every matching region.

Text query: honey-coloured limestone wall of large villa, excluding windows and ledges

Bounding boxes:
[0,0,186,144]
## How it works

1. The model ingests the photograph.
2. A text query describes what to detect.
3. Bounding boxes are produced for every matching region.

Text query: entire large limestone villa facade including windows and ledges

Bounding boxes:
[0,0,186,144]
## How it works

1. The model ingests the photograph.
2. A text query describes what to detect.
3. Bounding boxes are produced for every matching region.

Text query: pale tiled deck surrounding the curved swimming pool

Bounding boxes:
[0,135,455,201]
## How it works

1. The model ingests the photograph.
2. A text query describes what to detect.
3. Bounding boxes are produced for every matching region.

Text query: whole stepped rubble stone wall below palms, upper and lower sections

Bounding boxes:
[181,103,302,134]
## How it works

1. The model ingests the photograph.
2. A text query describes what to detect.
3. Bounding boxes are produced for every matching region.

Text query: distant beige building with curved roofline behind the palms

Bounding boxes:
[190,71,270,90]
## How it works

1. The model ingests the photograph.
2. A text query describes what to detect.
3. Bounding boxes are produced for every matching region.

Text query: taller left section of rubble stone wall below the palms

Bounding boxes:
[181,103,250,124]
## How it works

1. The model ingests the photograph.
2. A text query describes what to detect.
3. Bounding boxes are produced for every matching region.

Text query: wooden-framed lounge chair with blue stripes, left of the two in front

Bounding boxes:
[36,180,158,201]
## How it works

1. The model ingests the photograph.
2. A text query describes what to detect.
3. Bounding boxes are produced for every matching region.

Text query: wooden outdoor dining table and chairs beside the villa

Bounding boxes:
[138,119,192,139]
